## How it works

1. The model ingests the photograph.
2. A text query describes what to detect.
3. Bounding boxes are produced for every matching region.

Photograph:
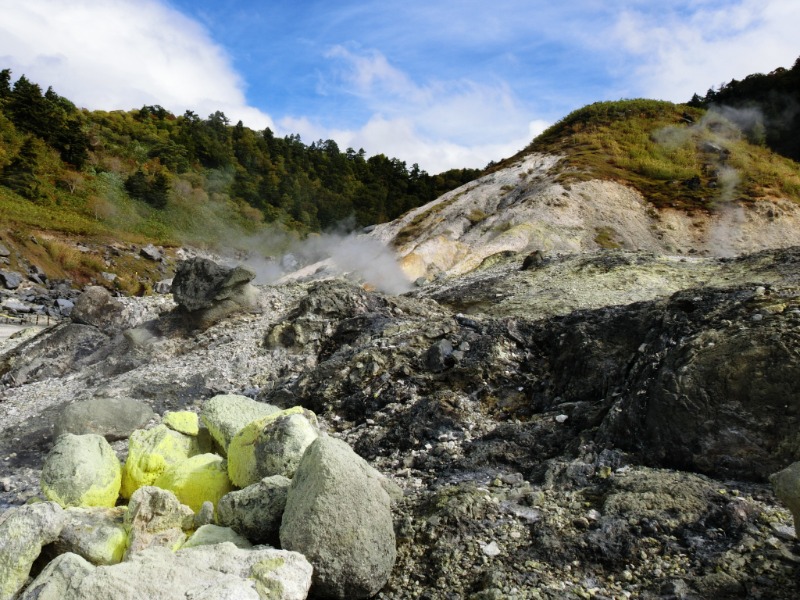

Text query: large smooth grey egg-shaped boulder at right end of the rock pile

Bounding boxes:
[280,436,396,599]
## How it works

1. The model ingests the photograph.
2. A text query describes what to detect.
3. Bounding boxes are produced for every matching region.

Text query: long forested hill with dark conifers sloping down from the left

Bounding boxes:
[0,69,480,240]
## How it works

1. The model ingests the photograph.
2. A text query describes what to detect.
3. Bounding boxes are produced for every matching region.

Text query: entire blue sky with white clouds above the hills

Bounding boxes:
[0,0,800,173]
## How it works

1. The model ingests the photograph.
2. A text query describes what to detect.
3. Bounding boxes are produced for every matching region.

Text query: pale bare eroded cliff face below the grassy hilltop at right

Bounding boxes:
[370,154,800,279]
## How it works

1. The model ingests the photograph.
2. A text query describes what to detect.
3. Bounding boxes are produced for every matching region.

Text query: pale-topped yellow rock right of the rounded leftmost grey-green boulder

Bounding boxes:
[120,424,199,498]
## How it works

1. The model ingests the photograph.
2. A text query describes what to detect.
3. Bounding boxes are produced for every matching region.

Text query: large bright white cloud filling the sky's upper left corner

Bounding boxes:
[0,0,272,128]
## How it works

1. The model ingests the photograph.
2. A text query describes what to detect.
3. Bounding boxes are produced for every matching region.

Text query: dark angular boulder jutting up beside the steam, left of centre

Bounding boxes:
[172,258,256,312]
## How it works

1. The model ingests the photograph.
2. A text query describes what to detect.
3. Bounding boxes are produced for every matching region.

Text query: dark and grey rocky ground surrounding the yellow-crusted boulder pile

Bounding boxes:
[0,243,800,599]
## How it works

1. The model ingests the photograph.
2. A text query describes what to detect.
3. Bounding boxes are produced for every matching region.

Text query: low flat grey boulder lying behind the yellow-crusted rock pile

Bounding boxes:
[53,397,156,442]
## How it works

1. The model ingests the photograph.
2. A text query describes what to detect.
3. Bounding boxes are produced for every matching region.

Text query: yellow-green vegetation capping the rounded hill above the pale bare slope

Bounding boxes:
[495,99,800,210]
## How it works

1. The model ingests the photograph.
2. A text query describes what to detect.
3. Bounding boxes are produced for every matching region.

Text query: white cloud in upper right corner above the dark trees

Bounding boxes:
[609,0,800,102]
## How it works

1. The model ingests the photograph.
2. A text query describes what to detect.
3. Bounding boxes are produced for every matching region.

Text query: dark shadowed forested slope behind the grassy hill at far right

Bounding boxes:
[689,58,800,162]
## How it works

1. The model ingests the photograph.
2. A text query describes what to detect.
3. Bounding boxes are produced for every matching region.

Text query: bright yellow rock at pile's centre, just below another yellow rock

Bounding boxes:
[153,454,231,512]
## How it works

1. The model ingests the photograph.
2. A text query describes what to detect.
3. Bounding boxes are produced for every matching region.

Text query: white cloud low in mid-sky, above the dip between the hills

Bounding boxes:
[298,46,547,173]
